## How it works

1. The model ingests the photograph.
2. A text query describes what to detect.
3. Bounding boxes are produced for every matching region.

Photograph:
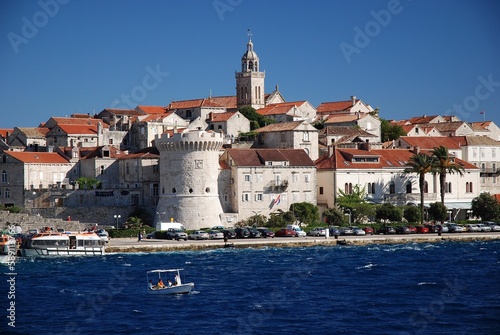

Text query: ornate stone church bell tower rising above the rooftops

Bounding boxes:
[236,33,266,109]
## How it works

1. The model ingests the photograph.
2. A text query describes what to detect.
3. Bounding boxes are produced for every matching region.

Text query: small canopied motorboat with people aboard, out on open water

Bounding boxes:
[146,269,194,294]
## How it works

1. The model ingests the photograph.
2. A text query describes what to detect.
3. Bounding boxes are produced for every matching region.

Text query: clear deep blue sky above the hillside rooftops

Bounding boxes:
[0,0,500,128]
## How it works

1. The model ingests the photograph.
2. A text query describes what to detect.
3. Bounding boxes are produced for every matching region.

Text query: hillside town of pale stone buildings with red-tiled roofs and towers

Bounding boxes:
[0,38,500,229]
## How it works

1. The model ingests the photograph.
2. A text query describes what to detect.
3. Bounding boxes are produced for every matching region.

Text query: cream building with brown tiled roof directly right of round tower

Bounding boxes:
[220,149,317,223]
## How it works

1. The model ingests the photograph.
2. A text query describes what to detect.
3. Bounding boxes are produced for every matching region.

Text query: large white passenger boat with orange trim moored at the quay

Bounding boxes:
[20,231,104,256]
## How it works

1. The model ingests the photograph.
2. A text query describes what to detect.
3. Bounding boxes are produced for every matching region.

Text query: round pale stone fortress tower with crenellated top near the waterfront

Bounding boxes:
[156,130,223,229]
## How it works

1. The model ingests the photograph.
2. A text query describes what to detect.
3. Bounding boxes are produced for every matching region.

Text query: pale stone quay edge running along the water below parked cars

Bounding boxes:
[106,232,500,253]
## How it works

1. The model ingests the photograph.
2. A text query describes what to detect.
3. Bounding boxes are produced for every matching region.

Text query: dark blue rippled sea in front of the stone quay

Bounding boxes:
[0,241,500,335]
